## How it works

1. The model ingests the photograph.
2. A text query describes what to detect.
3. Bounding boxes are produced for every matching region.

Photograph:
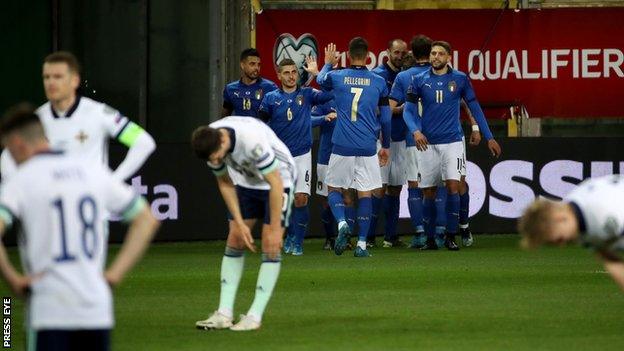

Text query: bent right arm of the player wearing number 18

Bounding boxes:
[104,197,160,286]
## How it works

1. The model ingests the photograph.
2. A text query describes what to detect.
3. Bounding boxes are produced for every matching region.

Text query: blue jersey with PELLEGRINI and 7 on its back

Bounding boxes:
[316,64,391,156]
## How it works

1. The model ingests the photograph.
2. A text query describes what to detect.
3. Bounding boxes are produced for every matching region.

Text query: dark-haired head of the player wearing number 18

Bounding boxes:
[0,103,48,164]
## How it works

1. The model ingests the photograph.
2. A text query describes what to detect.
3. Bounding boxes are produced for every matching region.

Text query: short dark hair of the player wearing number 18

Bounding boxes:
[0,102,45,138]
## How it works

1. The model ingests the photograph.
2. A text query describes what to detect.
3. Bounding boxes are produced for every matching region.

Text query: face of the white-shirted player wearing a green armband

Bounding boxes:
[43,62,80,101]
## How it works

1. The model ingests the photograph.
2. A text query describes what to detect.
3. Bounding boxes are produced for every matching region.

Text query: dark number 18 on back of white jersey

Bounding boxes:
[52,195,97,262]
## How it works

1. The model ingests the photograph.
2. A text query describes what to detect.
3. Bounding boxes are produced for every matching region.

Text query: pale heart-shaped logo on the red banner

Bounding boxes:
[273,33,318,85]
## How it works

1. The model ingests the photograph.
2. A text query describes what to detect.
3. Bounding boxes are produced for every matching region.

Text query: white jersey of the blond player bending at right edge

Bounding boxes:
[565,175,624,255]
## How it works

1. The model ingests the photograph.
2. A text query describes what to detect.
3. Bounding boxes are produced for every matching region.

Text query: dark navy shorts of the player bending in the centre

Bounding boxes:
[227,185,293,228]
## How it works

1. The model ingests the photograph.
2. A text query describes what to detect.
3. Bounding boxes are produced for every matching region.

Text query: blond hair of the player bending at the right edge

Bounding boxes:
[518,199,556,249]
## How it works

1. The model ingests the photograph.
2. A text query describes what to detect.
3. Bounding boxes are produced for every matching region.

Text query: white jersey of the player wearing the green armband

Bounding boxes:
[0,95,130,179]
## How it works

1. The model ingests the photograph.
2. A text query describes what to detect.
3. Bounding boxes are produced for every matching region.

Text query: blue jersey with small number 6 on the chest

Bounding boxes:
[258,88,334,157]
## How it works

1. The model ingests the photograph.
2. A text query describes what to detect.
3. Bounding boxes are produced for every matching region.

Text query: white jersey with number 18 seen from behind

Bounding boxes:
[0,152,141,330]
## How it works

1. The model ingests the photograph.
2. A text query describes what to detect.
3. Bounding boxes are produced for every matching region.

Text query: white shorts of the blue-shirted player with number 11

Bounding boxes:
[417,141,466,188]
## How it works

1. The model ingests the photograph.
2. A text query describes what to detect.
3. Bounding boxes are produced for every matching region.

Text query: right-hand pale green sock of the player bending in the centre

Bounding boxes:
[247,254,282,322]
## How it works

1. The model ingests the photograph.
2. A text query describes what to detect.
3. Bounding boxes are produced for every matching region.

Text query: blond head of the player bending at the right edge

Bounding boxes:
[518,199,579,249]
